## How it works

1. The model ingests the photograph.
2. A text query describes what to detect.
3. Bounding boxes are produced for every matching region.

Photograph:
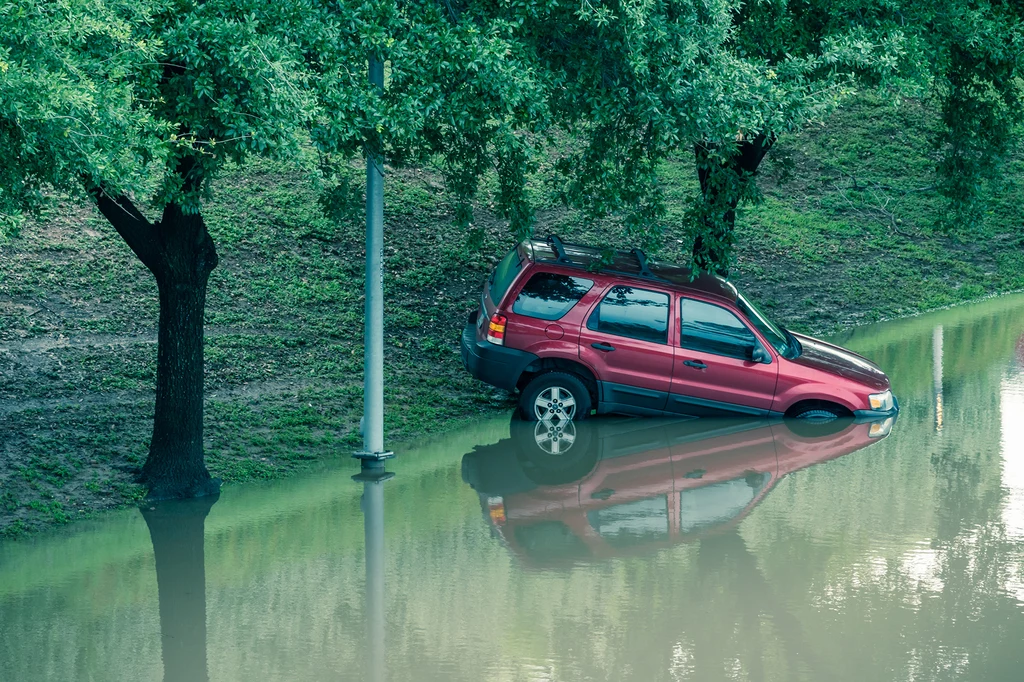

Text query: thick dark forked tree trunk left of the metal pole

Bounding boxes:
[93,176,220,493]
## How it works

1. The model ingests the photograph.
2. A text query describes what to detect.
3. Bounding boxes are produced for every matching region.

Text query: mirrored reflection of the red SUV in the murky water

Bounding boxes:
[462,417,895,565]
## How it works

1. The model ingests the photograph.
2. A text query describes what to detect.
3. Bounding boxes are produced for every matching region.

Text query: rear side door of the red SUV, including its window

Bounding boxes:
[580,285,675,414]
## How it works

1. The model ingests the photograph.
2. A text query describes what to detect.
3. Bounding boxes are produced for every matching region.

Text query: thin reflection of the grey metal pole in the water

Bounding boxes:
[352,460,394,682]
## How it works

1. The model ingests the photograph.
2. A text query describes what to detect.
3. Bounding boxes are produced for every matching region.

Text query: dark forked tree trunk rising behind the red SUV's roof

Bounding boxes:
[693,133,775,276]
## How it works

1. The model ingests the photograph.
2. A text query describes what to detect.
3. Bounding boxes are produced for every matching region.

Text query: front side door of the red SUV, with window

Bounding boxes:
[668,296,779,416]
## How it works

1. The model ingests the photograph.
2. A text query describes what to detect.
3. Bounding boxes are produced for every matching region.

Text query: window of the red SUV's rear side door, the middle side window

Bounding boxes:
[587,287,669,343]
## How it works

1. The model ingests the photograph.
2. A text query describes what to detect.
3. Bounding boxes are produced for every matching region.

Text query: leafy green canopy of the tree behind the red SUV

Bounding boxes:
[350,0,903,268]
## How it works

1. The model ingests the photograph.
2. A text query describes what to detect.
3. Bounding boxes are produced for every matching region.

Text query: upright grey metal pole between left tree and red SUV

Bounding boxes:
[355,50,392,460]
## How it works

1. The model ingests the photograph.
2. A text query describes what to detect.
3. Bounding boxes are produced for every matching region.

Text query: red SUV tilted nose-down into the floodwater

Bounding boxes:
[462,237,898,422]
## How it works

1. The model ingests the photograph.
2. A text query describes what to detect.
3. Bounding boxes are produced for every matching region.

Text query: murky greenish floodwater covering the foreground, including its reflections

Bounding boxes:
[0,296,1024,682]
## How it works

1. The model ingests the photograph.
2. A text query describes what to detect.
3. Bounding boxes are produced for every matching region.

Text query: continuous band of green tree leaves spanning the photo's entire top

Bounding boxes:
[6,0,1024,268]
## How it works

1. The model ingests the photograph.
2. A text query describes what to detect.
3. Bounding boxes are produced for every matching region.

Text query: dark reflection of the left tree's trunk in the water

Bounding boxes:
[140,495,220,682]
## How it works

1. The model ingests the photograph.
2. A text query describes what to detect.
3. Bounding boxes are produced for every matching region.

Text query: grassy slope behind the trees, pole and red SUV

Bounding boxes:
[0,95,1024,536]
